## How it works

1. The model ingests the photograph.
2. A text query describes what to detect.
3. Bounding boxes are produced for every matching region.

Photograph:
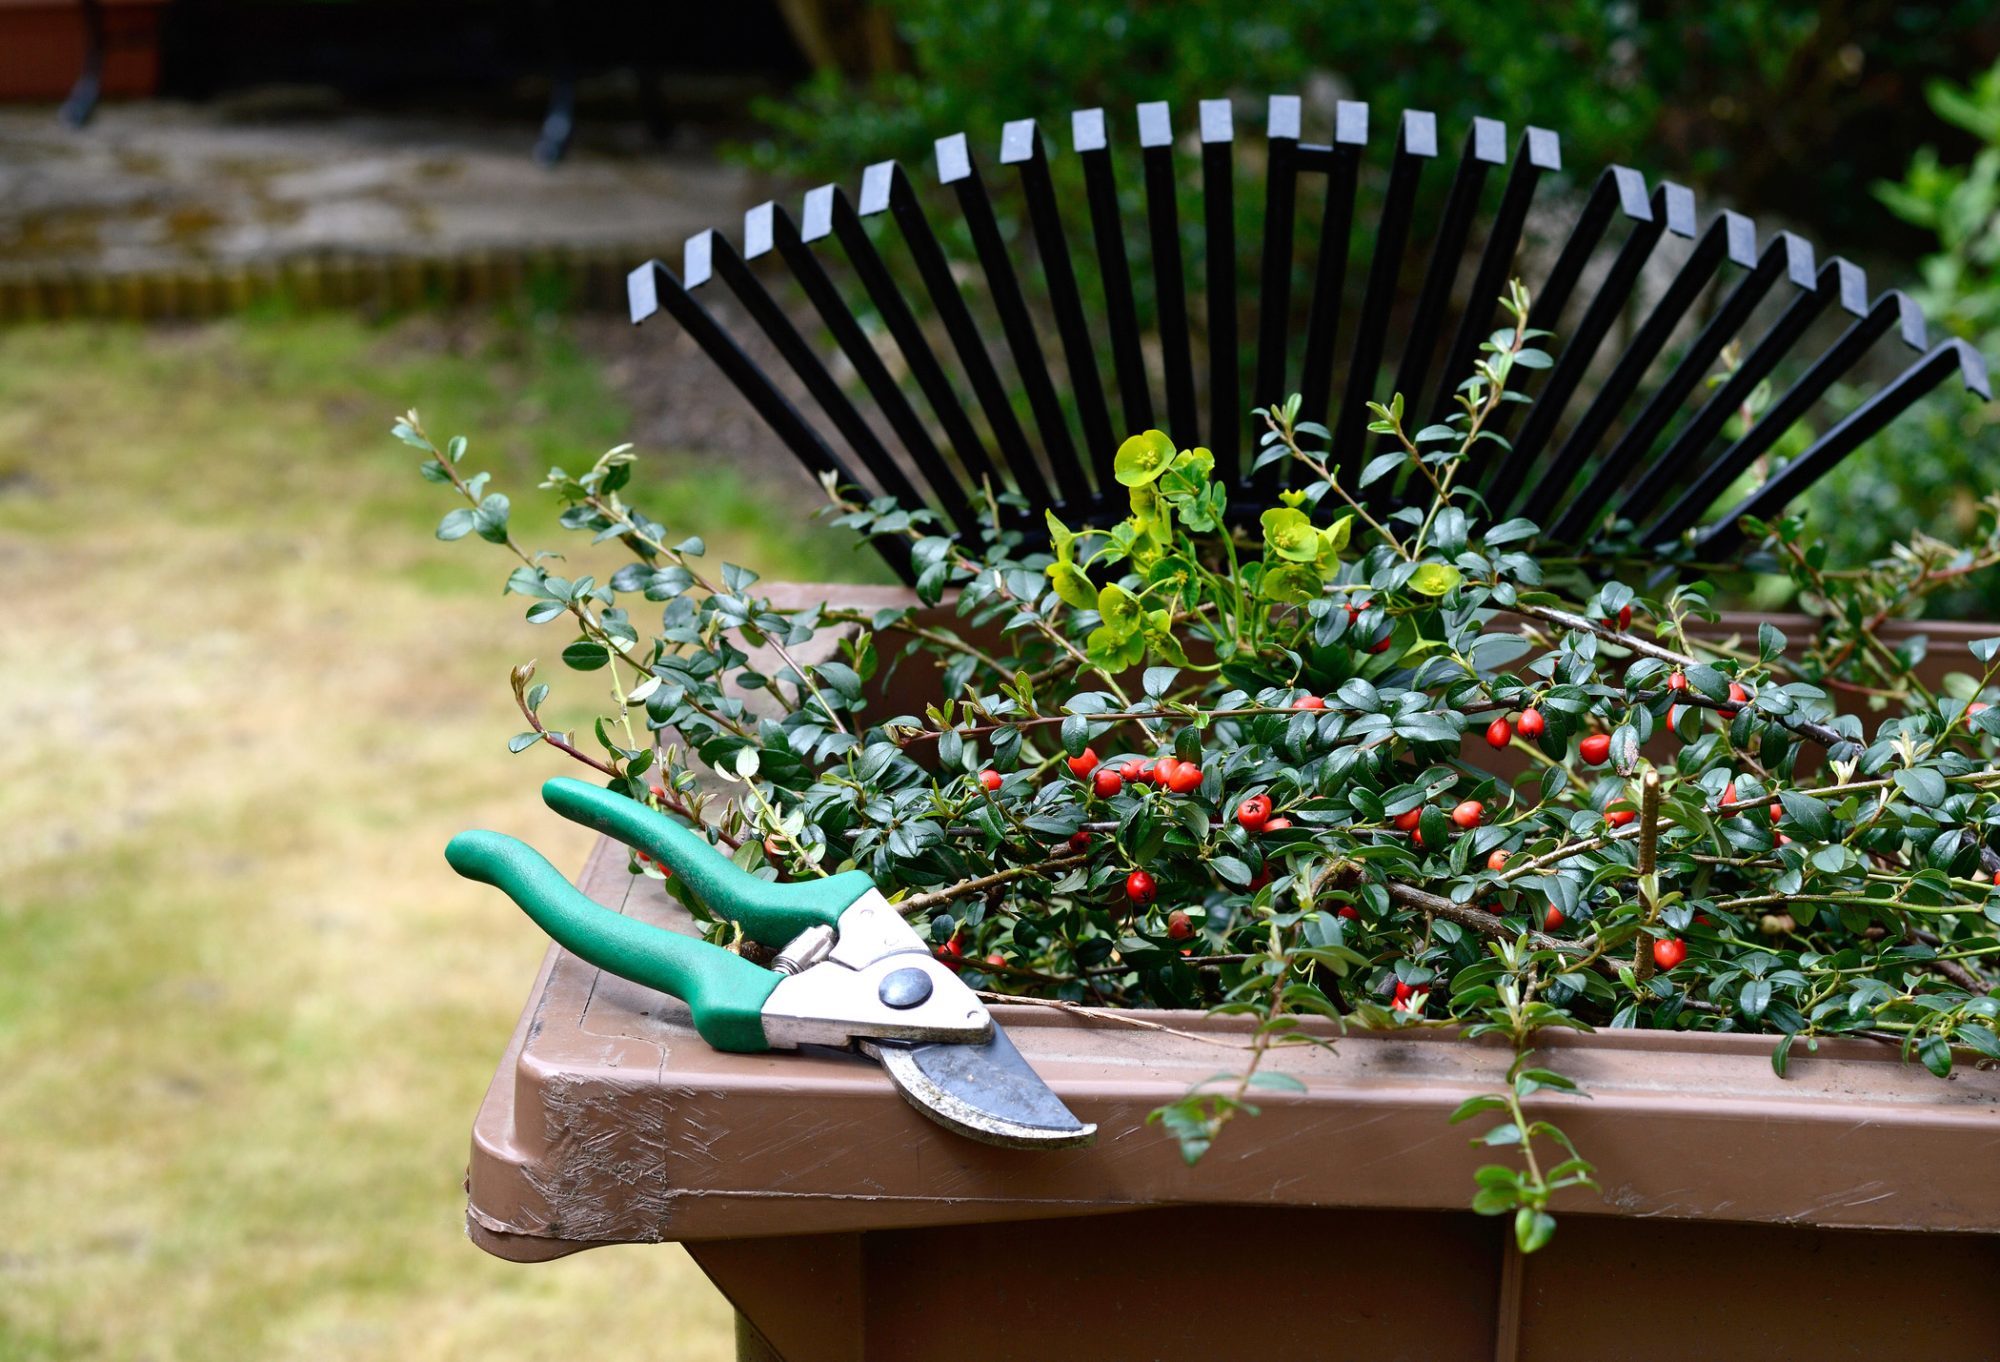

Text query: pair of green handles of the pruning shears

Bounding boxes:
[444,780,874,1050]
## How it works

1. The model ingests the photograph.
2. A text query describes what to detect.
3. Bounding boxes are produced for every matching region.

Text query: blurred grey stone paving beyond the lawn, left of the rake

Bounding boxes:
[0,102,768,276]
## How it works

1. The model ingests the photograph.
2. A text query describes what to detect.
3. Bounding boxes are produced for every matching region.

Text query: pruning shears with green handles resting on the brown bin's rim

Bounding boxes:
[444,778,1096,1148]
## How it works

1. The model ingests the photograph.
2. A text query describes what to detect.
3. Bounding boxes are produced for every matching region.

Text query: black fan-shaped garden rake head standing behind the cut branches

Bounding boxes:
[628,96,1990,574]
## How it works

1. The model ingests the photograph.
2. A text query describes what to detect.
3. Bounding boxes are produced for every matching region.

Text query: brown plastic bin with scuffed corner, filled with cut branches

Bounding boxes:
[466,588,2000,1362]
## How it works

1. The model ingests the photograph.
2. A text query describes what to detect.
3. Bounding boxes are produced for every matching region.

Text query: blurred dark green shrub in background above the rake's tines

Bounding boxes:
[748,0,2000,239]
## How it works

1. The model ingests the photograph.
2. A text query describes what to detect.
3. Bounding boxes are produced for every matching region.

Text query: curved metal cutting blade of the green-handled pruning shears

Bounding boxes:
[862,1024,1098,1150]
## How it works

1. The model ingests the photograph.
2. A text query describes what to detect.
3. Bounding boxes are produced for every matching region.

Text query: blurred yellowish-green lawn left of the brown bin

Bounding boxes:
[0,316,876,1362]
